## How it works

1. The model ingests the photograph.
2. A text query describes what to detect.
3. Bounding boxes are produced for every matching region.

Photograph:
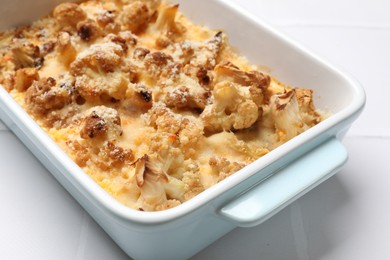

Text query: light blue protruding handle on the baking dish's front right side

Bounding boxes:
[218,137,348,227]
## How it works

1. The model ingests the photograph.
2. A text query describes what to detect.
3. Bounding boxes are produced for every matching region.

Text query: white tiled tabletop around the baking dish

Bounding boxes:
[0,0,390,260]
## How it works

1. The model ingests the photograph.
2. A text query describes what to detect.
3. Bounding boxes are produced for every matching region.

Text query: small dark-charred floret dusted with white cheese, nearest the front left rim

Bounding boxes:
[80,106,122,140]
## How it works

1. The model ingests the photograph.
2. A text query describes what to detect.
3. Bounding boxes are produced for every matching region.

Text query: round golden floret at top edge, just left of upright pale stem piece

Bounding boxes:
[120,1,151,33]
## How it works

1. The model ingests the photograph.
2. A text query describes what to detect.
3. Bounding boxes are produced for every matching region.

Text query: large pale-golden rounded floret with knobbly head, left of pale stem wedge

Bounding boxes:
[201,81,261,133]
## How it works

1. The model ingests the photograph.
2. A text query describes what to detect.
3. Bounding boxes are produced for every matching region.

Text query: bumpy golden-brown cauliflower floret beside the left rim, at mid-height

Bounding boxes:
[25,78,73,116]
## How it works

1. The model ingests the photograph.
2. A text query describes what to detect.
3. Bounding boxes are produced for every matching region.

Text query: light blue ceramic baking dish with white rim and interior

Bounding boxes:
[0,0,365,259]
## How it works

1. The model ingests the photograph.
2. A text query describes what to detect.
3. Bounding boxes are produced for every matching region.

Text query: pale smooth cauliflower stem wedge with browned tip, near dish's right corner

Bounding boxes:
[270,90,308,142]
